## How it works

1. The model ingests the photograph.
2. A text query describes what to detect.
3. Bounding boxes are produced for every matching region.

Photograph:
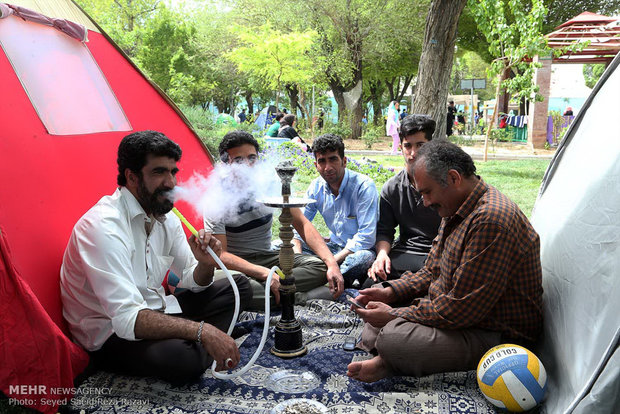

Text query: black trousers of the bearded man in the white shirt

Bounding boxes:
[91,274,252,384]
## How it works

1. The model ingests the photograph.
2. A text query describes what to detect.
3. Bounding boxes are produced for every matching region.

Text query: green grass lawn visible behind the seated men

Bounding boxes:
[273,155,550,238]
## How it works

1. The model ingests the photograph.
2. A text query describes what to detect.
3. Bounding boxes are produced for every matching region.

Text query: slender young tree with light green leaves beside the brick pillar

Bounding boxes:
[469,0,551,161]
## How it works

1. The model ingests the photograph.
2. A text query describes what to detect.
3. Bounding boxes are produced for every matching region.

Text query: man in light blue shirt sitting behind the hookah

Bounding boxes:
[294,134,377,287]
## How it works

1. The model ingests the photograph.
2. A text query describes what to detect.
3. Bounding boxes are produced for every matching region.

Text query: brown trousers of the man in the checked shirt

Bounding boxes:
[358,318,501,377]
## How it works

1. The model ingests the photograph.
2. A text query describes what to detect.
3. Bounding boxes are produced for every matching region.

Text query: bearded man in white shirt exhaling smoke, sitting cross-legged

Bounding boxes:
[60,131,252,384]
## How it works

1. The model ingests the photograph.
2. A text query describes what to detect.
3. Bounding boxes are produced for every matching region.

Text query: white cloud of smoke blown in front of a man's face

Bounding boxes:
[172,160,282,222]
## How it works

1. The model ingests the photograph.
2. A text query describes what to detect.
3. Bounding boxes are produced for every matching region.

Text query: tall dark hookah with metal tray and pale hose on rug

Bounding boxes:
[172,161,314,379]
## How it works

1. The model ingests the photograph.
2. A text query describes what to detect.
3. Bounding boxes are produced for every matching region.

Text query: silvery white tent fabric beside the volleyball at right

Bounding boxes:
[532,51,620,413]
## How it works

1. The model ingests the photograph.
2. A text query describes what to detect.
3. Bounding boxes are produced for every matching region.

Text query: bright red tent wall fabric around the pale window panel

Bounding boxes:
[0,1,212,332]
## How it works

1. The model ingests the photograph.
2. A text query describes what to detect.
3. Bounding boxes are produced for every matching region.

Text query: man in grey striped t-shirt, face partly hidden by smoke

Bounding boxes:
[205,131,344,309]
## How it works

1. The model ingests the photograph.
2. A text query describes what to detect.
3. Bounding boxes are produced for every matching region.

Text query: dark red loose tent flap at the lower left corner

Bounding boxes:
[0,228,88,413]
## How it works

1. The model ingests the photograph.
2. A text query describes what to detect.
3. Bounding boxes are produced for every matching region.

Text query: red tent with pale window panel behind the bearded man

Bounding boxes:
[0,0,212,410]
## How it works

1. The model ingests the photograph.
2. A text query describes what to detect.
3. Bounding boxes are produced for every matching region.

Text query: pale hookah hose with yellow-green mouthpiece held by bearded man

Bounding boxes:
[172,207,282,379]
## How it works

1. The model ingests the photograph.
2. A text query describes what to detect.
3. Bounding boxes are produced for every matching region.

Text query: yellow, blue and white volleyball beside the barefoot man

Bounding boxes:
[478,344,547,411]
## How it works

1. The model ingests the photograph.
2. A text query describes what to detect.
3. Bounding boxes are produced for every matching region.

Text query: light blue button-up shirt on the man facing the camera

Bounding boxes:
[303,169,379,253]
